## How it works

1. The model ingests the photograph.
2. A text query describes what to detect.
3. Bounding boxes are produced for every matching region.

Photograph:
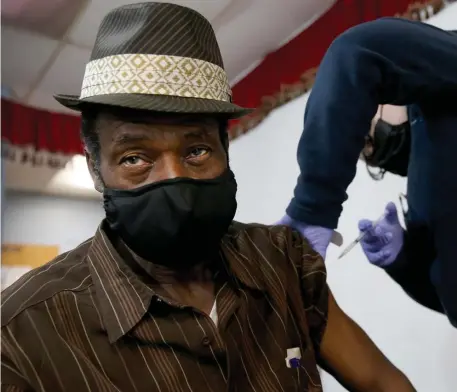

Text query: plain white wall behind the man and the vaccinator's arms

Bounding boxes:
[230,4,457,392]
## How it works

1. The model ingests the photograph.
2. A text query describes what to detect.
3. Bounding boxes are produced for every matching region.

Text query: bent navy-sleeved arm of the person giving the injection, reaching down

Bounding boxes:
[287,18,457,229]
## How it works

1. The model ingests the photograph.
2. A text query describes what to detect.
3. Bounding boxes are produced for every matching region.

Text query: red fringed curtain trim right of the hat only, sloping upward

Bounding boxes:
[228,0,444,135]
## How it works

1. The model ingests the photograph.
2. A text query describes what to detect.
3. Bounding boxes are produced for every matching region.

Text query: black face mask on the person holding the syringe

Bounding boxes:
[364,119,411,180]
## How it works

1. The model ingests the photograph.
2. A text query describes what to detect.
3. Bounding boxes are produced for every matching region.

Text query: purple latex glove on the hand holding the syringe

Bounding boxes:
[359,202,403,268]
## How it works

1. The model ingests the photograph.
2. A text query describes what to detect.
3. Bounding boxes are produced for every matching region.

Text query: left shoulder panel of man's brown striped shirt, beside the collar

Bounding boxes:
[1,238,92,327]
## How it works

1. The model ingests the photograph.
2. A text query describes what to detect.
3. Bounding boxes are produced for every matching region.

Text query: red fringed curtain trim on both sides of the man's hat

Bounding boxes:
[2,0,442,155]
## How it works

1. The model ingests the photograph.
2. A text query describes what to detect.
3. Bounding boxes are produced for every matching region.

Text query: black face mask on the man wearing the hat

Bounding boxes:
[104,170,237,268]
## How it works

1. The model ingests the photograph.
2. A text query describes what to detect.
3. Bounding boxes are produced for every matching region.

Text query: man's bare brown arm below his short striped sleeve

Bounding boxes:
[319,292,415,392]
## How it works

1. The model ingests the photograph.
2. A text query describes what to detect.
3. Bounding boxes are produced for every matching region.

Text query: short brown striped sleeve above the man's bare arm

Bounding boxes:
[290,231,329,352]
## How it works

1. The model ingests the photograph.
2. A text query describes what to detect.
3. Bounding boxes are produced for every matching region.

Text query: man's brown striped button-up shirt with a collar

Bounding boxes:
[1,223,328,392]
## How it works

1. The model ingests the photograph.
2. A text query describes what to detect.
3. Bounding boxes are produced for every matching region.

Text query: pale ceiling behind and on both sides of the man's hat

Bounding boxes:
[1,0,336,112]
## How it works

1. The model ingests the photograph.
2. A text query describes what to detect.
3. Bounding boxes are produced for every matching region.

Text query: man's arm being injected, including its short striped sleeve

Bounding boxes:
[287,231,414,392]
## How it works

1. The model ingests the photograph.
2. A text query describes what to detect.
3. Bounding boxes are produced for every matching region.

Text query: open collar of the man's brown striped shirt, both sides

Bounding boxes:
[87,222,269,343]
